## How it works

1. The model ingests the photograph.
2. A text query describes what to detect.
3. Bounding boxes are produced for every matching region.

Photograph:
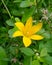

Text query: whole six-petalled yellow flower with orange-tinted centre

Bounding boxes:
[13,17,43,47]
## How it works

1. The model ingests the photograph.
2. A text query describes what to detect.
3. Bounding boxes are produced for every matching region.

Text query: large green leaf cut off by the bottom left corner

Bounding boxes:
[0,46,7,65]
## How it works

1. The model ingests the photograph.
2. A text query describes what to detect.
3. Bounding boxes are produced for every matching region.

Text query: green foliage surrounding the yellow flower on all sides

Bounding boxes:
[0,0,52,65]
